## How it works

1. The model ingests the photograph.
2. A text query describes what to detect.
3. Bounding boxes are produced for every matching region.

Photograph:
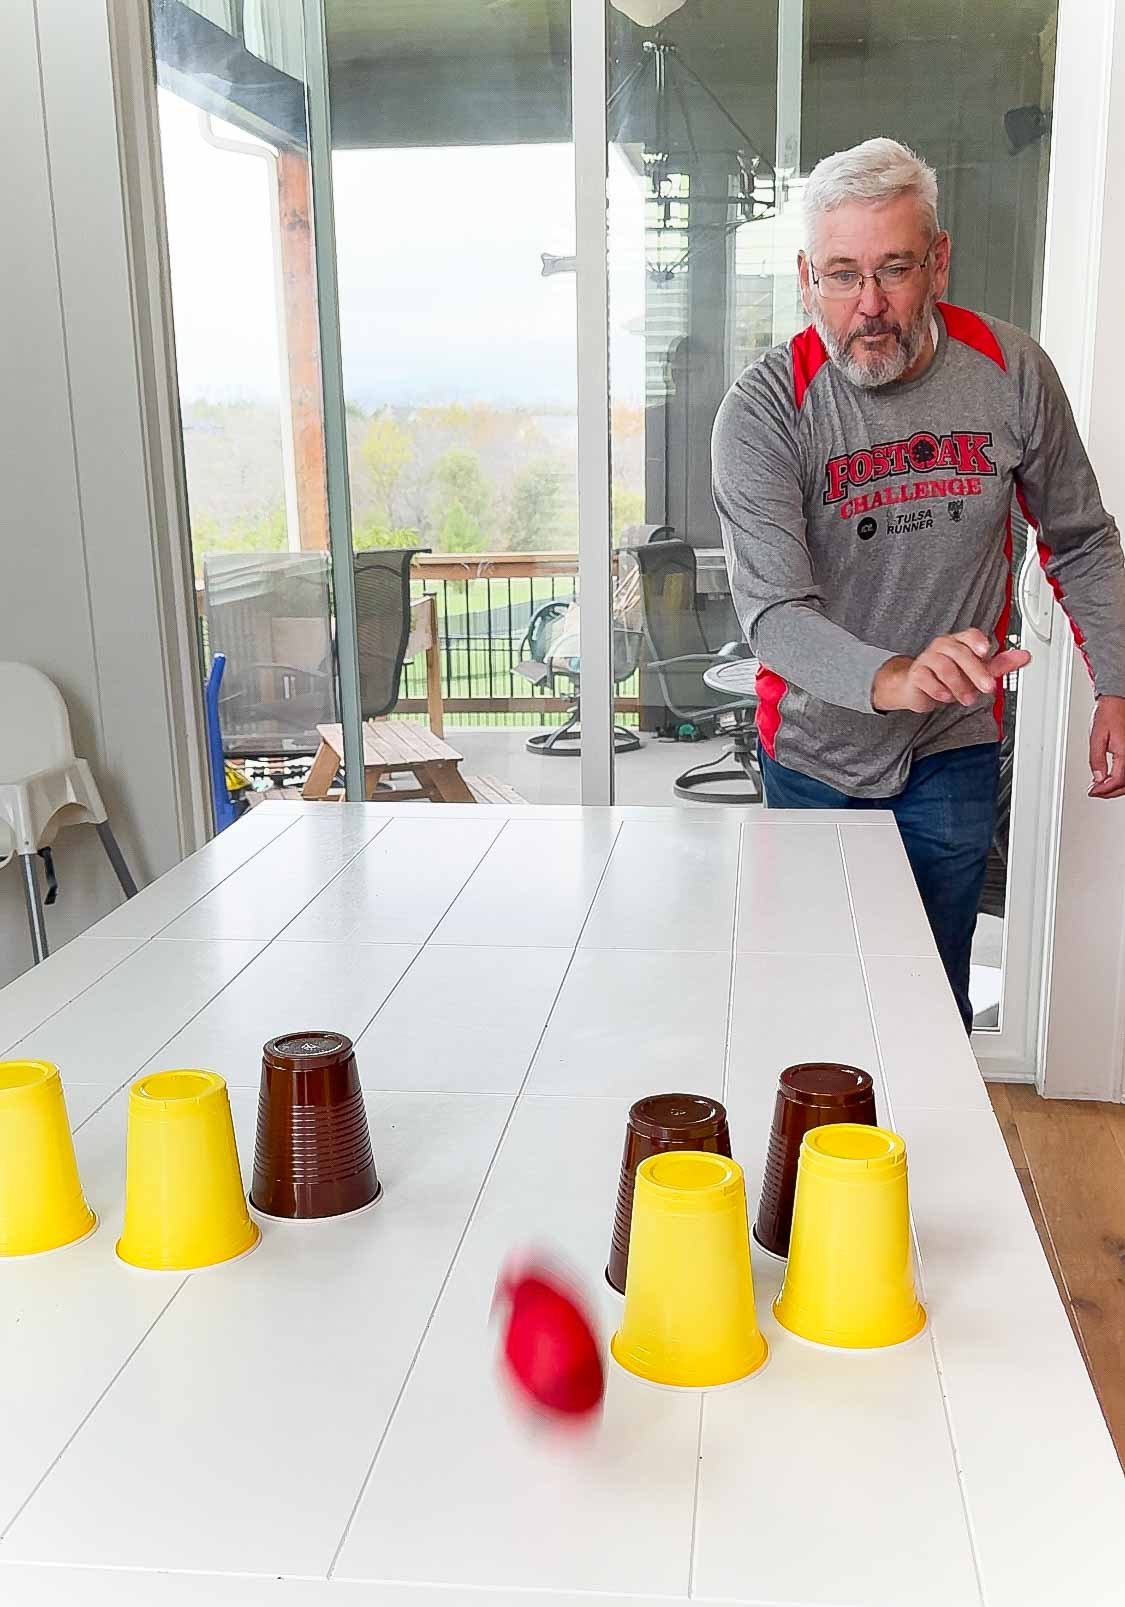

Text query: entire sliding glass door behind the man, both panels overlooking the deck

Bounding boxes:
[153,0,1056,1072]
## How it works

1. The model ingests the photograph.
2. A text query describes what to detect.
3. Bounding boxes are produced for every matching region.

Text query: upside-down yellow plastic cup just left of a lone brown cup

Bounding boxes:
[117,1070,262,1273]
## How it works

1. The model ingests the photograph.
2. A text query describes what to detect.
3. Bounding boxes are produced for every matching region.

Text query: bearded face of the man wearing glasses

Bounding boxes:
[797,196,950,387]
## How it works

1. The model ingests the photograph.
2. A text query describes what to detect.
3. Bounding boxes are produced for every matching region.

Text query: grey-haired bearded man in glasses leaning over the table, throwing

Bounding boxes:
[712,140,1125,1030]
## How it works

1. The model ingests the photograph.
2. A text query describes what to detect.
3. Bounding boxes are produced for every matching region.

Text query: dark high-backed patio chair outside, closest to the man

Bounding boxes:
[622,538,762,804]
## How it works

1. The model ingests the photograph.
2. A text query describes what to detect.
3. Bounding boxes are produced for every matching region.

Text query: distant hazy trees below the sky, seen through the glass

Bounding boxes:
[183,400,644,569]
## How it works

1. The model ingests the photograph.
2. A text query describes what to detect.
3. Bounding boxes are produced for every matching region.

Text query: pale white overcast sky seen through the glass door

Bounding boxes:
[161,90,644,408]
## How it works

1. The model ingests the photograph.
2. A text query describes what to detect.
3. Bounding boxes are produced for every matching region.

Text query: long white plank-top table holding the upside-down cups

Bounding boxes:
[0,804,1125,1607]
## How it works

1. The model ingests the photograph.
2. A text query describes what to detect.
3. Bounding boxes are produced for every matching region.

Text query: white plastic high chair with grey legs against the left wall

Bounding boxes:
[0,662,137,964]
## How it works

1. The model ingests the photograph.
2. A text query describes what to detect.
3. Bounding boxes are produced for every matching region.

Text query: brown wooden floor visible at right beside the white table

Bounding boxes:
[988,1083,1125,1467]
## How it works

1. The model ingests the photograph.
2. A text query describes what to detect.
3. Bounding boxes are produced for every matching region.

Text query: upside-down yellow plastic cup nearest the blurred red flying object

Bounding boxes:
[611,1149,770,1390]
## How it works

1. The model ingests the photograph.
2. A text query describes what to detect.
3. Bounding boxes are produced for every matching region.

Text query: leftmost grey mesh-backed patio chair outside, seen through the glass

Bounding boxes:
[203,553,339,759]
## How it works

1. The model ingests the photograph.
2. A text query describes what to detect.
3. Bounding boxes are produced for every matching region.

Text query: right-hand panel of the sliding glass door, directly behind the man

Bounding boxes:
[597,0,1058,1073]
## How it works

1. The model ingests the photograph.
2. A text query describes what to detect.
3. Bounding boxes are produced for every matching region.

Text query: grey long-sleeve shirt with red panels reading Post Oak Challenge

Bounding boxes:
[712,305,1125,797]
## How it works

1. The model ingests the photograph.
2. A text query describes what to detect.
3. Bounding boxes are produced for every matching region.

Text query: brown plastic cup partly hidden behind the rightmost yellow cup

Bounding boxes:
[754,1061,878,1260]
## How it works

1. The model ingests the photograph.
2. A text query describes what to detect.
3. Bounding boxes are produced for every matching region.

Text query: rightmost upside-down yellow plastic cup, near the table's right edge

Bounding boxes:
[773,1122,926,1350]
